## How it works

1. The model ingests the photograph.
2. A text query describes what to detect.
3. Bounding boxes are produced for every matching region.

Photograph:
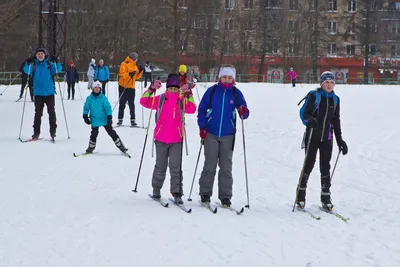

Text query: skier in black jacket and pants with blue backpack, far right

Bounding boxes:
[296,71,348,210]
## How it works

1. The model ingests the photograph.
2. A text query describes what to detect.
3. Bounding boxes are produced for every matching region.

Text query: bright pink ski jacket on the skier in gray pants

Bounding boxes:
[140,91,196,144]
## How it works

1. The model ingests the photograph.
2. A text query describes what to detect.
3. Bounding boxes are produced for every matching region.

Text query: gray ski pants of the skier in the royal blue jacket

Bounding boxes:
[199,133,233,200]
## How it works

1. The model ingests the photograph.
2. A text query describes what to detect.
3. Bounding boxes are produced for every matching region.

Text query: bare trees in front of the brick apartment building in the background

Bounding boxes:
[0,0,400,82]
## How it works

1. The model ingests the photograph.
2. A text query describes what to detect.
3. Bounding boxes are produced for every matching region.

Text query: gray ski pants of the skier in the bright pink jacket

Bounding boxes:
[152,141,183,194]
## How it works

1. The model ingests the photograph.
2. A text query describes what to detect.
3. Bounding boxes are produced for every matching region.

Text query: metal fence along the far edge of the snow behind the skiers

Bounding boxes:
[0,72,400,85]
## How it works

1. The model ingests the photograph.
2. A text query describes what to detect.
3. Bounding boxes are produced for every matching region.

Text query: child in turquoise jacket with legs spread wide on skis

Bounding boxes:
[83,81,128,153]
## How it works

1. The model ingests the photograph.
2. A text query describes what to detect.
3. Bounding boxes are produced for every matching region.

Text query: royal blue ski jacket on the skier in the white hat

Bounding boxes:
[197,84,250,137]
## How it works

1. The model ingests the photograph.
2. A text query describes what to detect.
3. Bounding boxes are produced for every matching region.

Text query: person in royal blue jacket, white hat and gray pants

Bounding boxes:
[197,65,249,207]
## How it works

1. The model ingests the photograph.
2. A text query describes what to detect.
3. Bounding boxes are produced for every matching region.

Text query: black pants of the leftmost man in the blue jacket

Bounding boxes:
[33,95,57,136]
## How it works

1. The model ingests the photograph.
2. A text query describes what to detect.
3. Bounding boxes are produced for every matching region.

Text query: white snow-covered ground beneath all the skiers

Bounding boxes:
[0,83,400,267]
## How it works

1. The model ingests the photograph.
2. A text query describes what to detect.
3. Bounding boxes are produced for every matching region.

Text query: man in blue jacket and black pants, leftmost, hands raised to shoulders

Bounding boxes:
[24,48,61,140]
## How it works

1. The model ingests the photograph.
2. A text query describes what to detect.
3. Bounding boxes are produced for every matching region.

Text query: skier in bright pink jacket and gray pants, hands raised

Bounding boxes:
[140,74,196,204]
